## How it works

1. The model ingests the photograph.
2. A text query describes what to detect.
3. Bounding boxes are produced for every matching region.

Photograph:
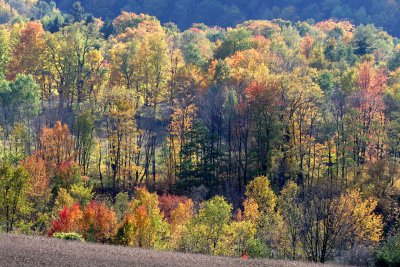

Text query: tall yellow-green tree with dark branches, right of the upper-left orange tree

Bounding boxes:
[43,22,101,113]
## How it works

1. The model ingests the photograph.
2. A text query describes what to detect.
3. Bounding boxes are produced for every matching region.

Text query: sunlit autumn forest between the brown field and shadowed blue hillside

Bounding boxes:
[0,0,400,266]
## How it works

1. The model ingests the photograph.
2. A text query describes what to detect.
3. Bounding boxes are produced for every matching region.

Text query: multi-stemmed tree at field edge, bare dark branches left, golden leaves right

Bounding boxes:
[300,187,382,262]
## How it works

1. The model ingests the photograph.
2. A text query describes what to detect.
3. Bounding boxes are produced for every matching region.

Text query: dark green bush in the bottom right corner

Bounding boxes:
[374,235,400,267]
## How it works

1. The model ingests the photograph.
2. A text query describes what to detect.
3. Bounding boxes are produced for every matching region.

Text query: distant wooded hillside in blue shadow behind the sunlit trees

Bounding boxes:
[54,0,400,35]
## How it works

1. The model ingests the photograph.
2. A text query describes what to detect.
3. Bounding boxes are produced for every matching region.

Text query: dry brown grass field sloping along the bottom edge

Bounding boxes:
[0,235,350,267]
